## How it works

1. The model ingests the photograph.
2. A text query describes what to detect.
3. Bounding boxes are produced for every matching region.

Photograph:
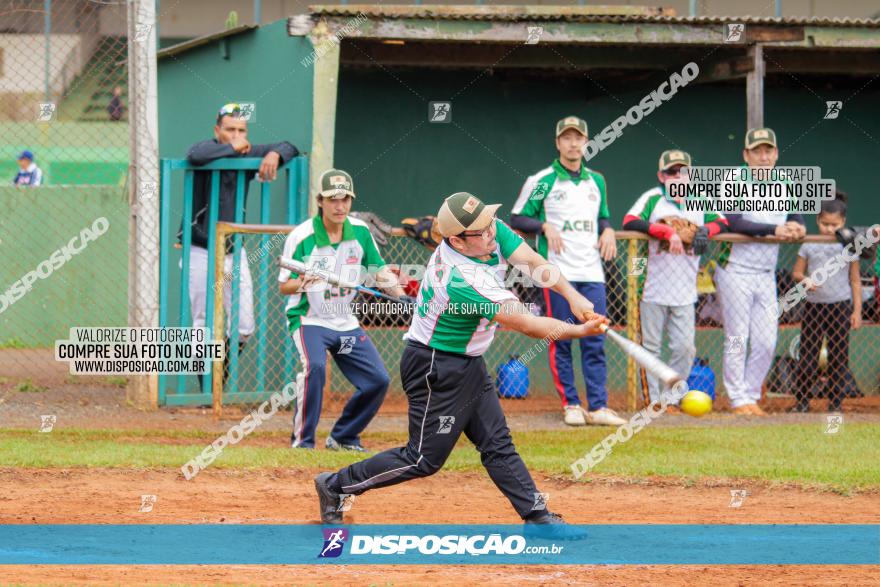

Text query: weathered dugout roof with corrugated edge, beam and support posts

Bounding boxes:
[287,4,880,203]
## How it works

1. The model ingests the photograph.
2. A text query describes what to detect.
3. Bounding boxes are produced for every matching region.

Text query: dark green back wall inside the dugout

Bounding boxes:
[335,69,880,234]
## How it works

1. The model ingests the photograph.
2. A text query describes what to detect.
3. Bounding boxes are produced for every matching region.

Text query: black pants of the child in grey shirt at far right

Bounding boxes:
[795,302,853,407]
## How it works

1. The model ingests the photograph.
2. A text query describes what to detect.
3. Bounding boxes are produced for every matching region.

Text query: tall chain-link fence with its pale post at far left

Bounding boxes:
[0,0,159,403]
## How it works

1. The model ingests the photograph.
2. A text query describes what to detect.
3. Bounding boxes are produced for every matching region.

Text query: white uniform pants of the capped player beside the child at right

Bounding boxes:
[715,267,778,408]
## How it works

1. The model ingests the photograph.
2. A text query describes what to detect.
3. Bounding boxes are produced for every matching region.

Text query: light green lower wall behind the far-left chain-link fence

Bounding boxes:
[0,186,128,347]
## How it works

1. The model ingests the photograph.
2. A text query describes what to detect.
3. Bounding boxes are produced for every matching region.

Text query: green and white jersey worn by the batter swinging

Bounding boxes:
[404,219,523,357]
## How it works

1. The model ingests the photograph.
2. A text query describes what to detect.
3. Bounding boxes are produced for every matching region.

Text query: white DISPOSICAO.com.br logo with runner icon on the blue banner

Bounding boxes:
[319,528,564,558]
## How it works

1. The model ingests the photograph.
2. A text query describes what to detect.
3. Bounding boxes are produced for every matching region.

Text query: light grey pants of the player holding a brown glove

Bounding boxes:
[639,302,697,403]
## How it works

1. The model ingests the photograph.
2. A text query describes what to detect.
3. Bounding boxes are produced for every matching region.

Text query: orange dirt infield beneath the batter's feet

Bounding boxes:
[0,469,880,585]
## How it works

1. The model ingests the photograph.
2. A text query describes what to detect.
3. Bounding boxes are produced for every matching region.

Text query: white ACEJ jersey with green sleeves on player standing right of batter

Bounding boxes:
[513,160,610,282]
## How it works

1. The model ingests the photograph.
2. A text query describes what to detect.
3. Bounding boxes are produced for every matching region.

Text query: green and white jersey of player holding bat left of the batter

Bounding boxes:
[278,216,385,332]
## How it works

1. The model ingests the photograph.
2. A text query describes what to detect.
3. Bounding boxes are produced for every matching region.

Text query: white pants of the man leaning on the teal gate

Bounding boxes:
[189,246,255,342]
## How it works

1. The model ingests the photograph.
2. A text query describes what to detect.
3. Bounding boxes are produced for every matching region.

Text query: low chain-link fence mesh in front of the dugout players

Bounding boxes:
[208,227,880,409]
